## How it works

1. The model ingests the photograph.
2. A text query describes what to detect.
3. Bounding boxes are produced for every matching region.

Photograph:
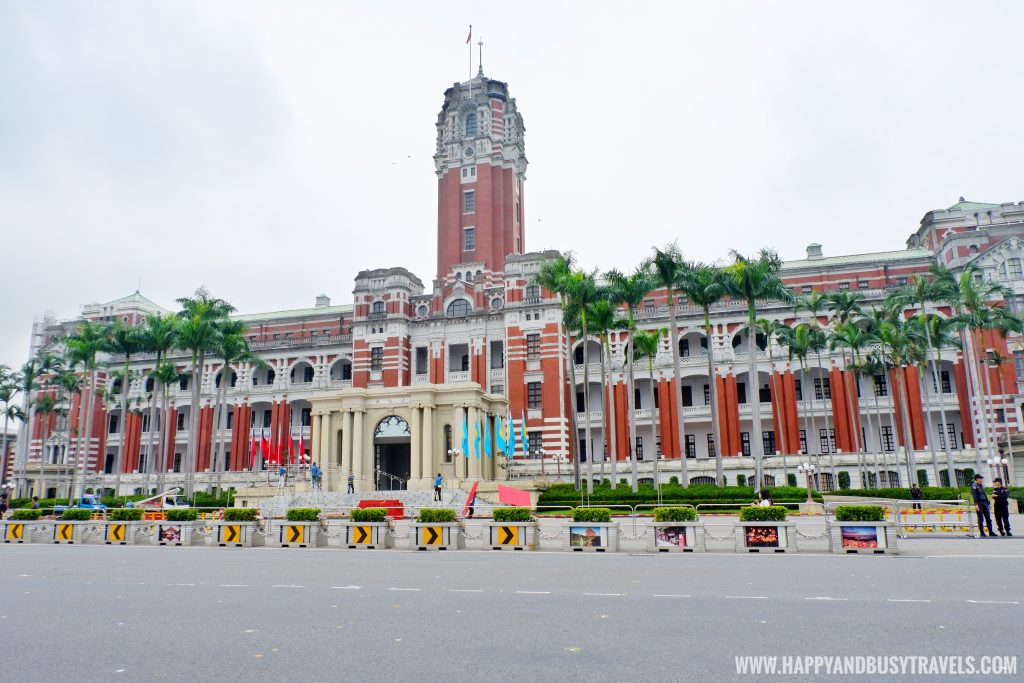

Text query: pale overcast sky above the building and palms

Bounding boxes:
[0,0,1024,366]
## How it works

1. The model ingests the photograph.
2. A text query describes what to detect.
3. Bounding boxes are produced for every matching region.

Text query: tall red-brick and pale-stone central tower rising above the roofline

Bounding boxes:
[434,71,526,281]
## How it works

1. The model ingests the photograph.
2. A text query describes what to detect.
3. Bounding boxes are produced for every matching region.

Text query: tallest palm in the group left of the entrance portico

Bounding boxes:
[177,287,234,497]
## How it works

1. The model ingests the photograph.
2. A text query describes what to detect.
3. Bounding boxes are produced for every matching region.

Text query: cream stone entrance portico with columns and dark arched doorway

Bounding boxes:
[311,382,508,492]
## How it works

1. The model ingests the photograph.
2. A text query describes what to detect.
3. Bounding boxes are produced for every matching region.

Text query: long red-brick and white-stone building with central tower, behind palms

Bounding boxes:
[8,66,1024,495]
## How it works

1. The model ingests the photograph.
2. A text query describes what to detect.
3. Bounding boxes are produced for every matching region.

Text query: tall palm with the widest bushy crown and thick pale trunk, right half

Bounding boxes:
[725,249,793,487]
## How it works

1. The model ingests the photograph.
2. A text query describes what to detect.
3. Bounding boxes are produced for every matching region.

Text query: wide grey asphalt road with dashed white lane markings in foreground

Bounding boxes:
[0,545,1024,683]
